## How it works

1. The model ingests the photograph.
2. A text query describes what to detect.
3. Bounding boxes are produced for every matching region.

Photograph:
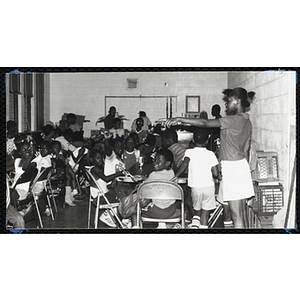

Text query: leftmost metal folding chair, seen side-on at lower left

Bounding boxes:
[29,167,54,228]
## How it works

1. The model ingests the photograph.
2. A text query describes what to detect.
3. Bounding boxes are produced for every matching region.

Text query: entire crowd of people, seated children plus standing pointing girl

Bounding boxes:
[6,88,254,228]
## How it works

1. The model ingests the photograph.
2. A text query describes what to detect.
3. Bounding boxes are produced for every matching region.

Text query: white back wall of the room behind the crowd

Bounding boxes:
[46,72,227,136]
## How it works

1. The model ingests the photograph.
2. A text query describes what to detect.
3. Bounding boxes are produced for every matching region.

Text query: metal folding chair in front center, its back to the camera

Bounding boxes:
[137,180,185,228]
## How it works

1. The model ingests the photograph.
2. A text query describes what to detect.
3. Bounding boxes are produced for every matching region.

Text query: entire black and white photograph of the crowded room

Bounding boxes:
[5,69,297,232]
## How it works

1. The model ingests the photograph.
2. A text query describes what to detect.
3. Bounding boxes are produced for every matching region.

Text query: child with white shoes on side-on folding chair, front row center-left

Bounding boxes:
[90,149,123,227]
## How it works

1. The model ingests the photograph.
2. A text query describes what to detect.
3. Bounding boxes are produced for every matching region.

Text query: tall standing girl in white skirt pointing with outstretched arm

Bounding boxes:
[166,87,255,228]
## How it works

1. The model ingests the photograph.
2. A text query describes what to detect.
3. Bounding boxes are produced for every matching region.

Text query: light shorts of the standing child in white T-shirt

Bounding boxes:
[191,186,216,210]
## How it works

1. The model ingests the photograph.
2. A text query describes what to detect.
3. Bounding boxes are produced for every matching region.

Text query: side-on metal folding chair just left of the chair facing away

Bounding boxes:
[85,167,125,229]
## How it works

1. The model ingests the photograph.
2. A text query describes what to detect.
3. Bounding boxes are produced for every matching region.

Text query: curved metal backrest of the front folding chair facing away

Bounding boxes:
[137,180,183,201]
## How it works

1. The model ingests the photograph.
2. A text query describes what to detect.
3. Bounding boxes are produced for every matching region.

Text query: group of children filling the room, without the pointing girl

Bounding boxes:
[8,113,219,228]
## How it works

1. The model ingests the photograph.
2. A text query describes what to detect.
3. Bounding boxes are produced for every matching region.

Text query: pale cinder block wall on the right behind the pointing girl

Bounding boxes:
[228,71,296,228]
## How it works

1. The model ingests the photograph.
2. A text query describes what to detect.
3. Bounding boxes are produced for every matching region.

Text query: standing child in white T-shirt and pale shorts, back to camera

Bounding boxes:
[176,128,219,228]
